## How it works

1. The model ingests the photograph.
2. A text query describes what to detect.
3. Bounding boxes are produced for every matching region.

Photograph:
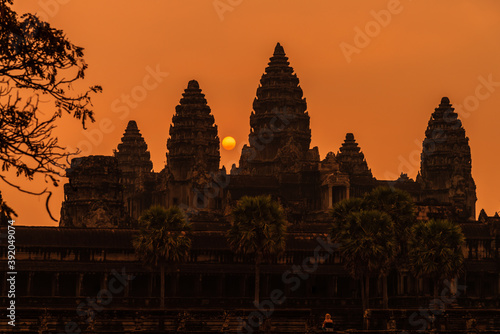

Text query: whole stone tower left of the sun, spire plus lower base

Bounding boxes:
[166,80,220,207]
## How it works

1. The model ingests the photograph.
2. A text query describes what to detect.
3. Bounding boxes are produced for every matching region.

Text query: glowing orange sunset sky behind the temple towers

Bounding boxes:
[2,0,500,225]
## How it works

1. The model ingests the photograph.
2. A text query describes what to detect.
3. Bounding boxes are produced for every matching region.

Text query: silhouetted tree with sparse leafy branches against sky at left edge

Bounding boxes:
[0,0,102,223]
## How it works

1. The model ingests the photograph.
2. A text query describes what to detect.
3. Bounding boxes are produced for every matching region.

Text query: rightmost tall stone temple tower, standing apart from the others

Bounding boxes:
[417,97,477,222]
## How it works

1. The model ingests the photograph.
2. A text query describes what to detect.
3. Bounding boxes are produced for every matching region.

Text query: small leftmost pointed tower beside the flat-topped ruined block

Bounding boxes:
[114,120,153,219]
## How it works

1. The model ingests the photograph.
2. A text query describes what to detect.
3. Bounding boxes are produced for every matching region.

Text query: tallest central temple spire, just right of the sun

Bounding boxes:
[240,43,311,174]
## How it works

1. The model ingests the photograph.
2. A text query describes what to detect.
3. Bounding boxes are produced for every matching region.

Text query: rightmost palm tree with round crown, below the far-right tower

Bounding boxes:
[408,219,465,298]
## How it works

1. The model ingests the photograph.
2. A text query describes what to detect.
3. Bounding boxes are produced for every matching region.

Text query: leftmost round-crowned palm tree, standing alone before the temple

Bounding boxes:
[133,206,191,308]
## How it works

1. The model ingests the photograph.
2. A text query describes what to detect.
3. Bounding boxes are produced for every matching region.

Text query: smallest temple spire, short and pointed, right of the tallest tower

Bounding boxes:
[337,133,373,179]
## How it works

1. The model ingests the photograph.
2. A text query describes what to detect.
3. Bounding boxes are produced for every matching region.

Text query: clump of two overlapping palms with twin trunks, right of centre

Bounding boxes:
[329,187,416,309]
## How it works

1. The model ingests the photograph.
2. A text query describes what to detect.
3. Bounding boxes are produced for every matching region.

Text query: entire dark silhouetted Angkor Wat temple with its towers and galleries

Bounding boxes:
[0,44,500,333]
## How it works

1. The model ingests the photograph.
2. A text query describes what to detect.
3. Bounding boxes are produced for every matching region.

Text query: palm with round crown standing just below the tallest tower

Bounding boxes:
[227,195,287,306]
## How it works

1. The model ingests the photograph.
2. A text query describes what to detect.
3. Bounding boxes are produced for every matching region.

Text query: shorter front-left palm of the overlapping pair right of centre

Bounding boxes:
[330,207,396,310]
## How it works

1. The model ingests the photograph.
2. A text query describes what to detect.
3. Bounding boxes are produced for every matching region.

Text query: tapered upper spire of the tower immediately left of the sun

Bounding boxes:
[167,80,220,181]
